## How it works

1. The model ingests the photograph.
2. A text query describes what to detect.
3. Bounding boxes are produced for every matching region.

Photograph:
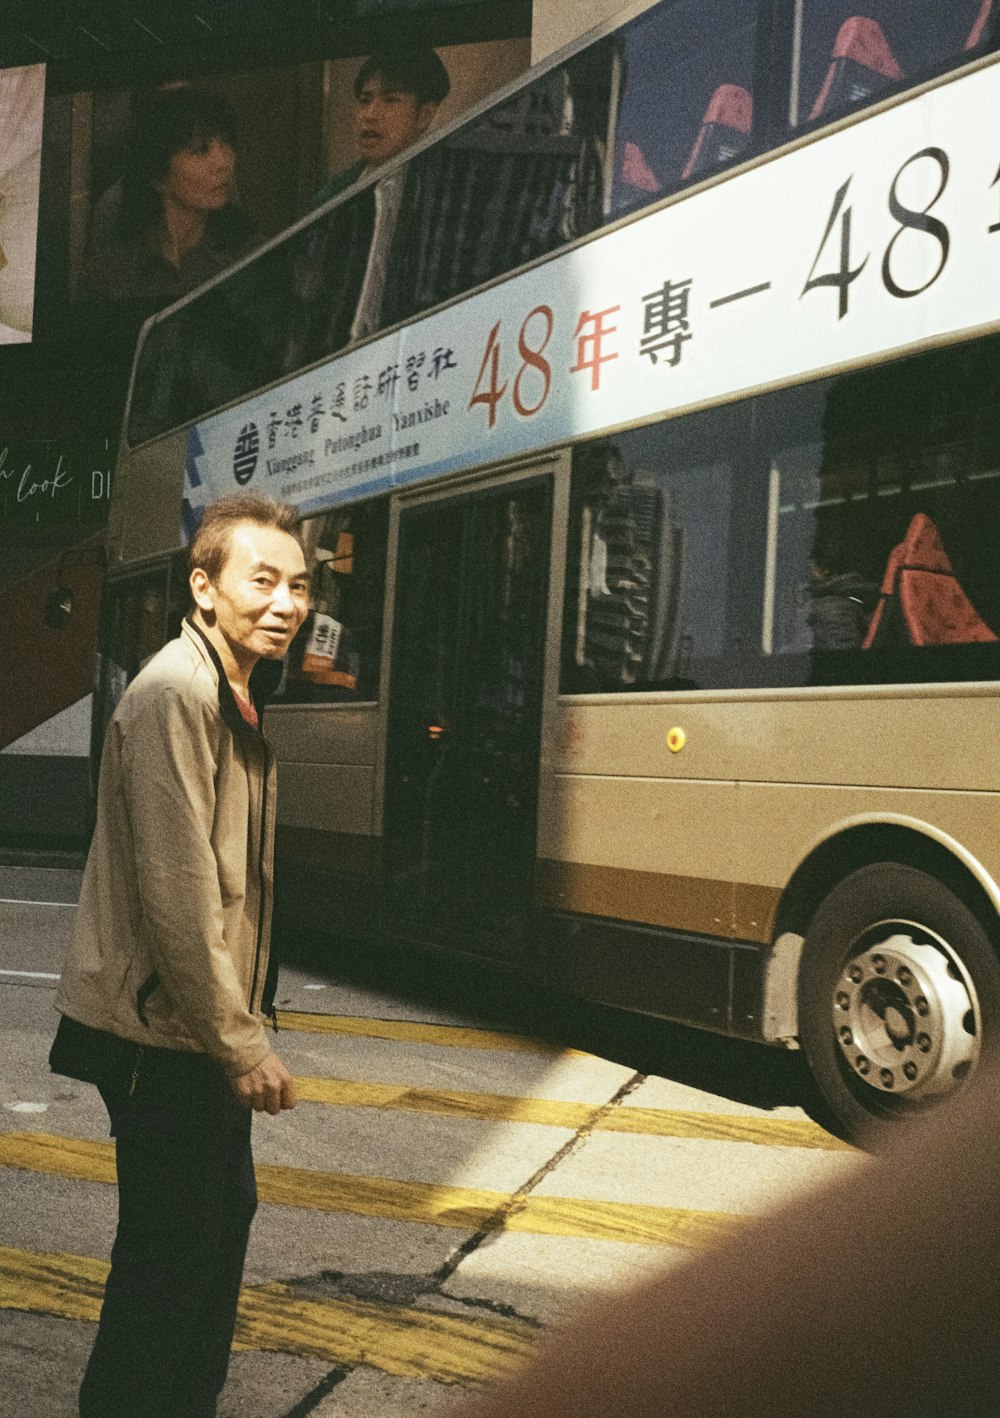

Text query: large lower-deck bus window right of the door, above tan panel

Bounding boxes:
[562,337,1000,693]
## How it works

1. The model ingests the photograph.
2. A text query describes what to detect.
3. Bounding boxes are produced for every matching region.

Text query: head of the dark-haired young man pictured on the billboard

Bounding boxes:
[313,47,451,207]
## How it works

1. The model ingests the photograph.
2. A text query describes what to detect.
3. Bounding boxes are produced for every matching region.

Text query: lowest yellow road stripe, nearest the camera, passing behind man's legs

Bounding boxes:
[0,1246,536,1384]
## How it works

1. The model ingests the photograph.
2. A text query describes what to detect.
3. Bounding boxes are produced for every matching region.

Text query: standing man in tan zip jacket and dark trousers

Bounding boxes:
[51,496,309,1418]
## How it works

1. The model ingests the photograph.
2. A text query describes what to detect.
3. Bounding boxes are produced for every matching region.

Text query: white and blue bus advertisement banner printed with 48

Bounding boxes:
[186,53,1000,527]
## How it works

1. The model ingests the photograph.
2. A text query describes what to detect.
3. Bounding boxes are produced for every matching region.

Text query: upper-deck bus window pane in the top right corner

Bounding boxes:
[793,0,997,123]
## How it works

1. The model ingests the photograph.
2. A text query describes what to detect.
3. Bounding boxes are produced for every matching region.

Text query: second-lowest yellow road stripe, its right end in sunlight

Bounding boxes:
[0,1133,739,1246]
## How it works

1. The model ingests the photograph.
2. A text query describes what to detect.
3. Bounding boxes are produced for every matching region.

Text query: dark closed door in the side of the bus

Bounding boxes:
[383,476,552,959]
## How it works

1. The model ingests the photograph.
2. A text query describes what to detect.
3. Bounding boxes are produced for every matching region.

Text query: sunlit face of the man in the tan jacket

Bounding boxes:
[191,522,309,659]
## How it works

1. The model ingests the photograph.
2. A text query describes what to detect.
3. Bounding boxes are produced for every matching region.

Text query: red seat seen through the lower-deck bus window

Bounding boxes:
[864,512,997,649]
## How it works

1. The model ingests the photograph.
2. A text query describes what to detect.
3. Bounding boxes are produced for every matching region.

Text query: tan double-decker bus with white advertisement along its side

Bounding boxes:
[96,0,1000,1133]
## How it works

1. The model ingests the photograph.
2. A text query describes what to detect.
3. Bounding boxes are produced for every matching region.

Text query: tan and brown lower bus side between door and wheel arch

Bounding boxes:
[535,691,1000,1038]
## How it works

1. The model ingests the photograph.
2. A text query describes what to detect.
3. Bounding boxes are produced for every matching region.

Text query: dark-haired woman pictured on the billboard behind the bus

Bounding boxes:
[81,85,254,305]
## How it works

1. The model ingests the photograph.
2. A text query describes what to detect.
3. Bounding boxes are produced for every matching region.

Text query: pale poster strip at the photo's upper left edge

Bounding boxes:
[0,64,45,345]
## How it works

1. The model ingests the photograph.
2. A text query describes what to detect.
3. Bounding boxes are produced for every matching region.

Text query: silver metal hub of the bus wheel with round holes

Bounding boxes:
[833,923,980,1100]
